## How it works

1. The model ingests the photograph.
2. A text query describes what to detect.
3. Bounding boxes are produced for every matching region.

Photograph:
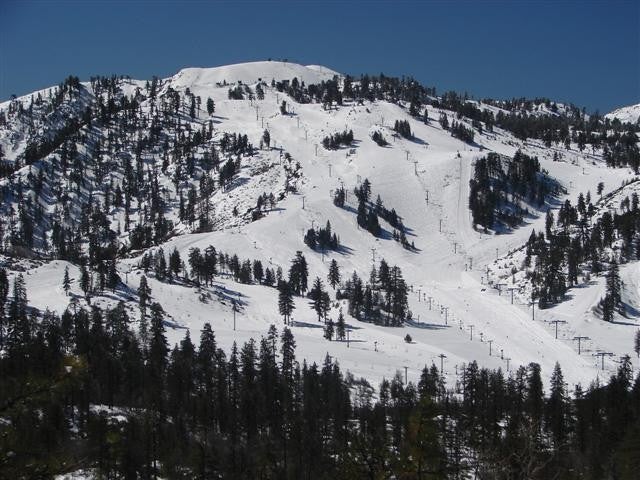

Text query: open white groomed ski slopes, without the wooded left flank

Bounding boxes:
[2,62,640,392]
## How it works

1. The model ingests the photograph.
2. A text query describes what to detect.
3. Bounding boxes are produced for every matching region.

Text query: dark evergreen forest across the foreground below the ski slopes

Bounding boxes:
[0,262,640,480]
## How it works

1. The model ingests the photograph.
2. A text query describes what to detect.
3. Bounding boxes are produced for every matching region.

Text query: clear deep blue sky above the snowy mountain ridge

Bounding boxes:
[0,0,640,113]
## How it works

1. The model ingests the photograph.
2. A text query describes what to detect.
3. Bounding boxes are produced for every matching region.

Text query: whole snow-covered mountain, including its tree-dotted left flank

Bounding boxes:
[0,62,640,385]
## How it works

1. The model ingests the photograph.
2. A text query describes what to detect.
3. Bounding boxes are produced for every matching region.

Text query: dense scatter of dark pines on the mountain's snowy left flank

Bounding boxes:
[0,73,280,270]
